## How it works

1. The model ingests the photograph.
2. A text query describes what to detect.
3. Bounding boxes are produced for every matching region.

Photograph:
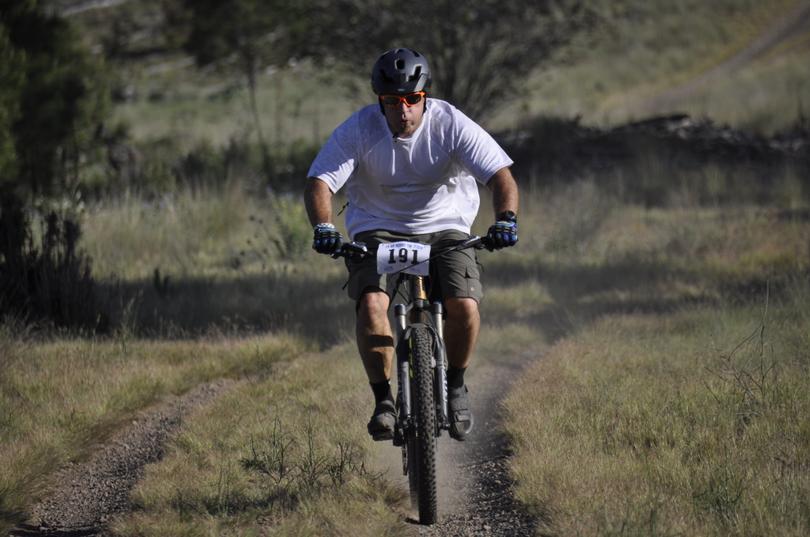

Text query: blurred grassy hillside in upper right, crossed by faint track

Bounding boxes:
[498,0,810,134]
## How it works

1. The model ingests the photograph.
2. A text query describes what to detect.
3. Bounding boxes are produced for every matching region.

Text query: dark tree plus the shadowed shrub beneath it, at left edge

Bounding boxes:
[0,0,107,325]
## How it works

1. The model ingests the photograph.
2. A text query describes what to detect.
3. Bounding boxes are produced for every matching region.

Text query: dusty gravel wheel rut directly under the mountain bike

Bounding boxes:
[380,349,542,537]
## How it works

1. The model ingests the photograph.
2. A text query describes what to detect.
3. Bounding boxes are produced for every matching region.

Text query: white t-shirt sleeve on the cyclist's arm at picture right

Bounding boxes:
[452,109,513,184]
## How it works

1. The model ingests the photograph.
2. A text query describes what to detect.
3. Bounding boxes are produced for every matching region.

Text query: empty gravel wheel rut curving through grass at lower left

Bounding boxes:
[11,380,235,536]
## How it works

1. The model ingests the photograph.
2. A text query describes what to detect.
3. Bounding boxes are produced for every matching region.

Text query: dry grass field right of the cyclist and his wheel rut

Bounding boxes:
[498,186,810,535]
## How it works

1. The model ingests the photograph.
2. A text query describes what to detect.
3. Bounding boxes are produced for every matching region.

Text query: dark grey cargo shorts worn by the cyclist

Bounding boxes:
[346,230,484,302]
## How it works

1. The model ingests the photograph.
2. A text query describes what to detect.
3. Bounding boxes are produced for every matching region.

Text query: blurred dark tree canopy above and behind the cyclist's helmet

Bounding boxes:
[164,0,597,126]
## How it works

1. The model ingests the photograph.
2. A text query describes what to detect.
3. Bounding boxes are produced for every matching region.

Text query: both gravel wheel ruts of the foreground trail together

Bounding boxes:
[10,349,542,537]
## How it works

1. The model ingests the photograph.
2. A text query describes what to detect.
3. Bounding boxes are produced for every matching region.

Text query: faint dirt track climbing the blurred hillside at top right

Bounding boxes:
[638,1,810,116]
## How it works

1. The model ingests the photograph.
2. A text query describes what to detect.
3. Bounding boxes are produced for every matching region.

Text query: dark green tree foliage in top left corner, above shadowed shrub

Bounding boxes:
[0,0,108,201]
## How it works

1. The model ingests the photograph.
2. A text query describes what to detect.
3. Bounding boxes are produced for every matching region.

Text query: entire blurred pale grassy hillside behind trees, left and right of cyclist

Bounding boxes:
[52,0,810,146]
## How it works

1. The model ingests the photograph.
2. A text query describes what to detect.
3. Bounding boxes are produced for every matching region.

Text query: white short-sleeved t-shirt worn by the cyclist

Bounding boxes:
[307,98,512,237]
